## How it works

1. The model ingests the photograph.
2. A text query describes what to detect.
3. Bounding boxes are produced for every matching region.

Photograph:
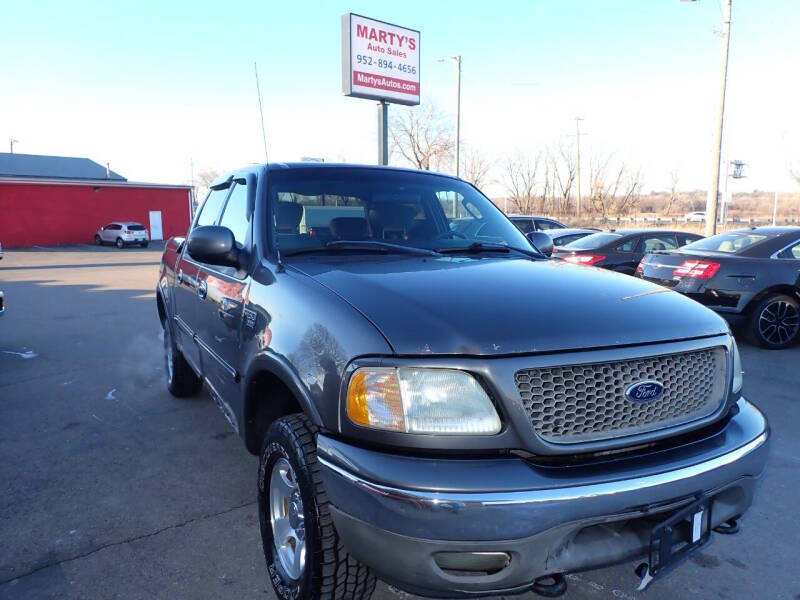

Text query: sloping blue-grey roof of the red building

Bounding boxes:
[0,152,127,181]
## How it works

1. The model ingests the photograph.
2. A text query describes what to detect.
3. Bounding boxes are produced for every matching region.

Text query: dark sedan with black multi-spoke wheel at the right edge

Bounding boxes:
[637,227,800,348]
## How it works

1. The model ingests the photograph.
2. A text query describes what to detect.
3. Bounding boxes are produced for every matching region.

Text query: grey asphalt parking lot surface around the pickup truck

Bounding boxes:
[0,244,800,600]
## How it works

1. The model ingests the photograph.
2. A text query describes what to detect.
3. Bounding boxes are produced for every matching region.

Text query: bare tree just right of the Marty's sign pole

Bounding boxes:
[389,103,455,171]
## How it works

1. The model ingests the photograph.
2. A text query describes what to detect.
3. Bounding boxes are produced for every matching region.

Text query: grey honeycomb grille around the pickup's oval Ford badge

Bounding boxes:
[515,347,727,443]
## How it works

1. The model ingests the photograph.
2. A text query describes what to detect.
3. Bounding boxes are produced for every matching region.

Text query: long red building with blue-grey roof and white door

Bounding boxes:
[0,153,192,248]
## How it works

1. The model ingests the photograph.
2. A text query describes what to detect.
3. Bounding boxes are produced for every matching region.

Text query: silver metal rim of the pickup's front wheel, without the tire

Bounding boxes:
[269,458,306,579]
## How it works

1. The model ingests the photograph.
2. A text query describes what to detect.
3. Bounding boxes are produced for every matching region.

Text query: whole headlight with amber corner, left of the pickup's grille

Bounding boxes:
[347,367,501,435]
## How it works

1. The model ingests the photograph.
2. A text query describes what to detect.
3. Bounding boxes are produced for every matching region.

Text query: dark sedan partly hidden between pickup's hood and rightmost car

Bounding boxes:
[553,229,703,275]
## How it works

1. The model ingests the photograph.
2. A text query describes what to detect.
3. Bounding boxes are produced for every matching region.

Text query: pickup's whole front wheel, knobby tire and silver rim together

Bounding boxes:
[258,414,376,600]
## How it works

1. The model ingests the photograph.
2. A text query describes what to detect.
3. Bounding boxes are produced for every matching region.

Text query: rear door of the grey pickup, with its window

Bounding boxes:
[173,185,230,373]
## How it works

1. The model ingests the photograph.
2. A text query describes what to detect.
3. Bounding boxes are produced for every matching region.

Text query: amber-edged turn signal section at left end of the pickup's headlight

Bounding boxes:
[347,369,405,431]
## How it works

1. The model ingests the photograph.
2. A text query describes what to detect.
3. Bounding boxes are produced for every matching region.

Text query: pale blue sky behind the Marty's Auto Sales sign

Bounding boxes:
[0,0,800,191]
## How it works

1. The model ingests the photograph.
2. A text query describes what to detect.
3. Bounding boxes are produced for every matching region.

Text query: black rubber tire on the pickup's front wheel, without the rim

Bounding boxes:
[258,414,376,600]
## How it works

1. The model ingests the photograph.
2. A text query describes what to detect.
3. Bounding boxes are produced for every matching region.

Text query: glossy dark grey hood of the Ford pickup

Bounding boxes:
[292,256,728,356]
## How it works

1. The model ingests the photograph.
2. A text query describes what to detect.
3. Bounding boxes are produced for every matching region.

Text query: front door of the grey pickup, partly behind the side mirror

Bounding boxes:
[191,179,250,430]
